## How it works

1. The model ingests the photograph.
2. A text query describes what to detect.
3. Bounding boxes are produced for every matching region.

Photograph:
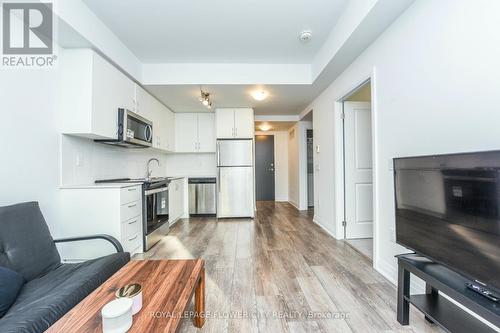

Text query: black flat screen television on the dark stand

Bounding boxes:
[394,151,500,294]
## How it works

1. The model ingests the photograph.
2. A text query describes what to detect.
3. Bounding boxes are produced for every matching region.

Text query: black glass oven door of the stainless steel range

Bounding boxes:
[144,186,168,235]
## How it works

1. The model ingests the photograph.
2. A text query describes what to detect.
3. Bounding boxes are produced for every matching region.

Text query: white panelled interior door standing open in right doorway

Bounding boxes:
[344,102,373,238]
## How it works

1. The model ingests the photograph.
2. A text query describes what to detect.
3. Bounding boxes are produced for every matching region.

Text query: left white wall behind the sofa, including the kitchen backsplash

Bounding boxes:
[0,46,166,237]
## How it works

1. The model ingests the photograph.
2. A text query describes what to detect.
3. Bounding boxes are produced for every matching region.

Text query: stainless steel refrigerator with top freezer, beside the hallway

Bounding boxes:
[217,139,255,218]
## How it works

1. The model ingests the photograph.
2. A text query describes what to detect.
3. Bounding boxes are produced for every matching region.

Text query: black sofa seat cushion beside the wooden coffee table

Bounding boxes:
[0,253,130,333]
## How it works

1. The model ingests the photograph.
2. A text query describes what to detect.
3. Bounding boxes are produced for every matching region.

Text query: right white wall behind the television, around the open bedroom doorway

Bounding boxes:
[304,0,500,288]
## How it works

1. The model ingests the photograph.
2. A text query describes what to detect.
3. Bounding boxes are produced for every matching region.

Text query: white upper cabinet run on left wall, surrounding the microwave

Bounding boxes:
[60,49,175,152]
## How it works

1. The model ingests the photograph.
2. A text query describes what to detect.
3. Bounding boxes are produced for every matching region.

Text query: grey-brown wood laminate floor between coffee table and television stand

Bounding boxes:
[135,202,441,333]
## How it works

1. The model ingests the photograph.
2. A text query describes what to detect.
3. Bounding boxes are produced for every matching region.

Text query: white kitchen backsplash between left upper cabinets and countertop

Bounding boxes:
[61,135,167,185]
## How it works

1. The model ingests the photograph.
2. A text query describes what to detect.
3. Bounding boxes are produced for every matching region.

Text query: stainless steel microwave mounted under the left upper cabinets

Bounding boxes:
[95,109,153,148]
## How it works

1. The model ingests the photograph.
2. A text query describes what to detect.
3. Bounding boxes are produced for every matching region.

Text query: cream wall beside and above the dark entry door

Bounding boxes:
[255,131,288,201]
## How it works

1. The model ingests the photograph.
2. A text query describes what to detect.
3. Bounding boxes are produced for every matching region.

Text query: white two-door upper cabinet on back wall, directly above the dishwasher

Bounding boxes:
[175,113,215,153]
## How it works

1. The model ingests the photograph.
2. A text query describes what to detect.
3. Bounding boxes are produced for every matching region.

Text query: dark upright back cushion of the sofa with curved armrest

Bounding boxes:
[0,202,61,281]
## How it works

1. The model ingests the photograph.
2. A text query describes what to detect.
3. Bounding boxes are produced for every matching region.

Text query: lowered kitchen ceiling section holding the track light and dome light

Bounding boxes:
[145,85,316,115]
